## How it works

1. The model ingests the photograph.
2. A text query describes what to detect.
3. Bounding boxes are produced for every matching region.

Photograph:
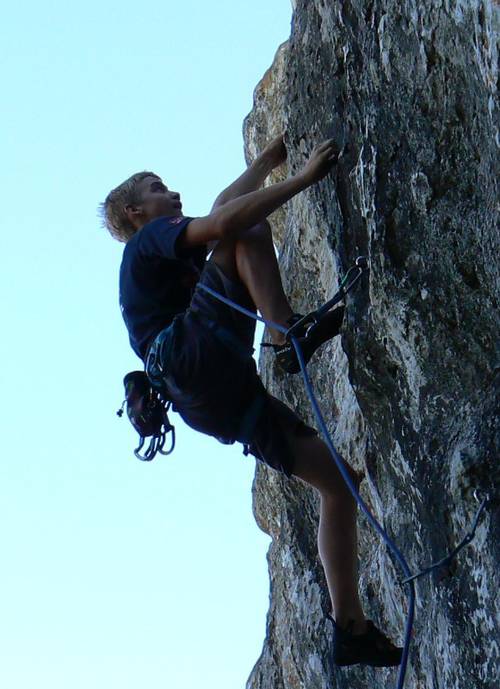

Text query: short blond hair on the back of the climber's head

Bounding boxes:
[99,171,159,242]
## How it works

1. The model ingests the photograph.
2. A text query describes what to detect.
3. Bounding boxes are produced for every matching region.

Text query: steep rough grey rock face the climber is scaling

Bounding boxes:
[244,0,500,689]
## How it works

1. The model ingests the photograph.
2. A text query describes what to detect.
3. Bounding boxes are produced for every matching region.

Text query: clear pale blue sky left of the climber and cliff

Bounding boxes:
[0,0,291,689]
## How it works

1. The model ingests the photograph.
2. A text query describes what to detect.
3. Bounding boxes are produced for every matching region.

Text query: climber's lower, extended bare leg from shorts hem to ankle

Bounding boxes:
[288,435,366,634]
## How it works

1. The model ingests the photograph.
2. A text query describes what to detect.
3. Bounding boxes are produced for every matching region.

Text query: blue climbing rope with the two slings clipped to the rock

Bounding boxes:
[198,256,487,689]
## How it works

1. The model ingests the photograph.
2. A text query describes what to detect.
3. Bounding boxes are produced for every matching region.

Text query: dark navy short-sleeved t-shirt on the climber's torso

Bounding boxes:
[120,217,207,360]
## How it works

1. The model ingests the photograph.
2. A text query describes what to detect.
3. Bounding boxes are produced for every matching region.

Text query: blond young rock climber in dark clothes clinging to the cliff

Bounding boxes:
[101,136,401,666]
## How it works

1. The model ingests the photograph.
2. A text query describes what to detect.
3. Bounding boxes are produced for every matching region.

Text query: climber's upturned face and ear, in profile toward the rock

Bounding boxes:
[125,175,182,228]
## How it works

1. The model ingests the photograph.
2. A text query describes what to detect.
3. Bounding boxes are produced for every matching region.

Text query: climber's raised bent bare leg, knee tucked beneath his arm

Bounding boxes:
[212,221,293,344]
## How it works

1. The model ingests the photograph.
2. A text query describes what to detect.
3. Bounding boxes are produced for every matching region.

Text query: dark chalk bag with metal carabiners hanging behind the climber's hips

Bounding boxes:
[116,371,175,462]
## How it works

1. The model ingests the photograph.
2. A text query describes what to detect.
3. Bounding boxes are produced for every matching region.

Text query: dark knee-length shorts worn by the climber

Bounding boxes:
[147,255,317,476]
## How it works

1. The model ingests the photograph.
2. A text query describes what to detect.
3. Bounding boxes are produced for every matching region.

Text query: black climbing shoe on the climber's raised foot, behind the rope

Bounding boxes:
[261,306,345,373]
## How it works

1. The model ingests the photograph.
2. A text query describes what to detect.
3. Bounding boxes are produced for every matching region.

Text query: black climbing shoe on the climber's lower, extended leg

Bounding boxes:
[327,614,403,667]
